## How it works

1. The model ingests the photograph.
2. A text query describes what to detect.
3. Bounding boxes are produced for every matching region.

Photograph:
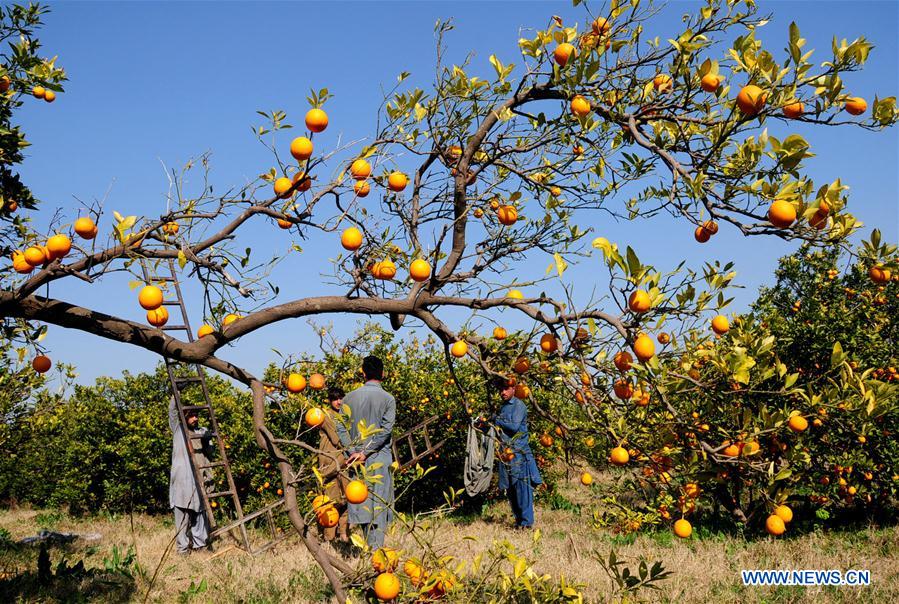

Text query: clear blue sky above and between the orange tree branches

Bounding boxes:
[16,2,899,382]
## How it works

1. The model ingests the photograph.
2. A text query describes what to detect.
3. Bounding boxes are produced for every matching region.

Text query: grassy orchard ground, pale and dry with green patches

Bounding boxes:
[0,476,899,604]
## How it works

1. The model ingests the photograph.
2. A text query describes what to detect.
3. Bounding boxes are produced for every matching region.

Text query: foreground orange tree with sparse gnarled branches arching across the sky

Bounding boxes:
[0,0,897,599]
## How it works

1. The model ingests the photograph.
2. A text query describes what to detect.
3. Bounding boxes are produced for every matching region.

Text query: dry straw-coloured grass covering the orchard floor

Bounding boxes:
[0,478,899,604]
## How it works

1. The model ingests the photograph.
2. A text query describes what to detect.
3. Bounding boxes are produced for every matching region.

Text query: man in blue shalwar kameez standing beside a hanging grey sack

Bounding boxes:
[493,378,543,528]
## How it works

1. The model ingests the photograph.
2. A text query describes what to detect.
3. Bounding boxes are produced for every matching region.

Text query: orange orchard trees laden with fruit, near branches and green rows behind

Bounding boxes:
[0,0,899,602]
